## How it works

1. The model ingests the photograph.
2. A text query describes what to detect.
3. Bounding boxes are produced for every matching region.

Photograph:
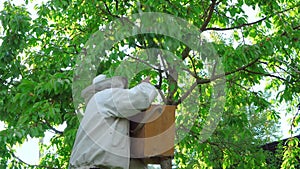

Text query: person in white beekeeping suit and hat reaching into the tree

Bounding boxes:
[69,75,157,169]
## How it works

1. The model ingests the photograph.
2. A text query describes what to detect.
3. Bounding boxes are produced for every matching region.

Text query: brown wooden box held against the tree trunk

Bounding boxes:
[130,105,176,164]
